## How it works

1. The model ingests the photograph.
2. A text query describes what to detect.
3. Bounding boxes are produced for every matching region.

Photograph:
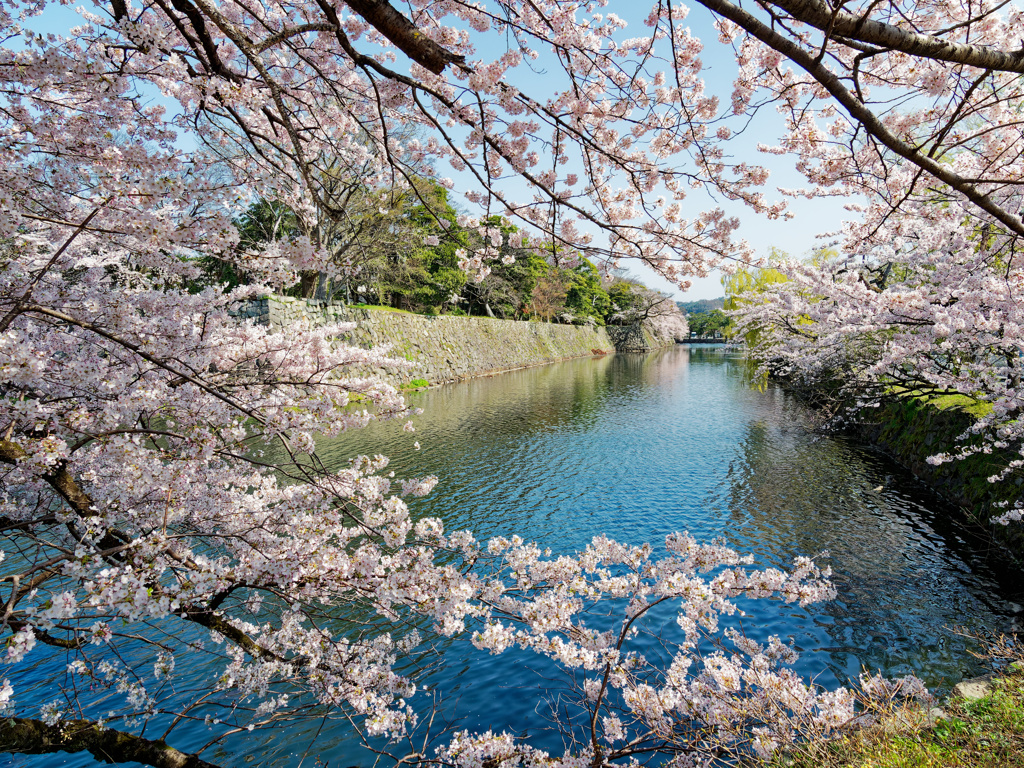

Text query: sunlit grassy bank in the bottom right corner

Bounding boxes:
[764,672,1024,768]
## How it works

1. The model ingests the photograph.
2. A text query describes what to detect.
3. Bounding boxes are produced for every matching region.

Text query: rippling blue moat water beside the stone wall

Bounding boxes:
[26,347,1021,768]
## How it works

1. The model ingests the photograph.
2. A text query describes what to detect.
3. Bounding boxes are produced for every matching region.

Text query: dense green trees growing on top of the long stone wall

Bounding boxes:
[212,201,671,326]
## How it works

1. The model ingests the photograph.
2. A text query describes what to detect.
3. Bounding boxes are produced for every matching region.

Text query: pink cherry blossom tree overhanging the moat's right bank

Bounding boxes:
[705,1,1024,519]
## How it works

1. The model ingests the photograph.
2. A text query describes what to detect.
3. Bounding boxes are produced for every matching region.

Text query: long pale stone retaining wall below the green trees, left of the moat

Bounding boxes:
[239,296,614,384]
